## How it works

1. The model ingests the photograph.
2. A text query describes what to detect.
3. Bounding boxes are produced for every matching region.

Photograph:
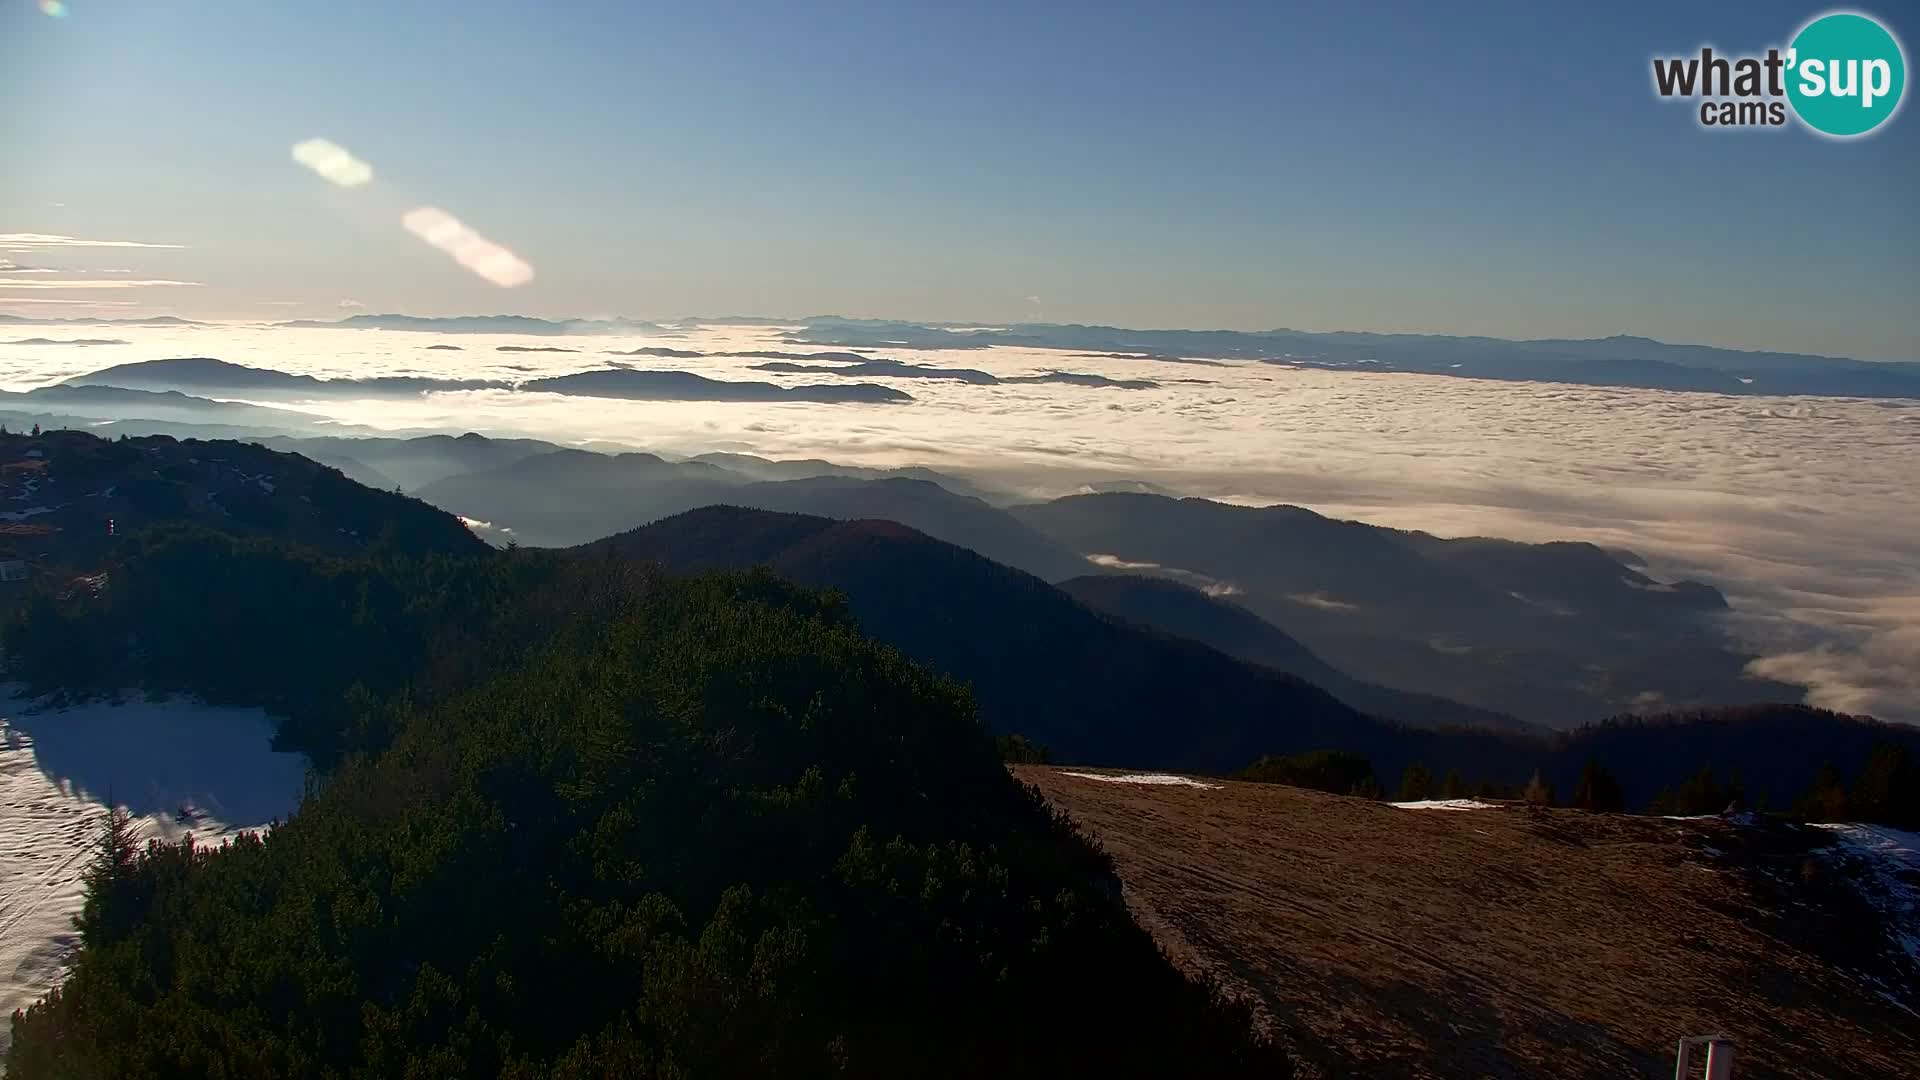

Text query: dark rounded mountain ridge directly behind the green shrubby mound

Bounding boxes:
[576,507,1482,771]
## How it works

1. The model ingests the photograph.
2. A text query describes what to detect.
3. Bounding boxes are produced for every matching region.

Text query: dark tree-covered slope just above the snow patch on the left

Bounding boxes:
[0,527,576,767]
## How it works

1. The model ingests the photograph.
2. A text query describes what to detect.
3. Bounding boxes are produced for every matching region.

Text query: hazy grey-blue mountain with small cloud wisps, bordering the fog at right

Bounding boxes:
[1010,492,1805,728]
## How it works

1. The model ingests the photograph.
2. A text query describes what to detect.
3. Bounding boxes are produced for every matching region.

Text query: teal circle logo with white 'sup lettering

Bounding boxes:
[1788,12,1907,138]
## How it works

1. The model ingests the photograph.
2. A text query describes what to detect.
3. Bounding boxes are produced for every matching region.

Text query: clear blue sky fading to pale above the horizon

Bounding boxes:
[0,0,1920,359]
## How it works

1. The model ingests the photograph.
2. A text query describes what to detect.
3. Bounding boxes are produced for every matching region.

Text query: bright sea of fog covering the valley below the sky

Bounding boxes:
[0,325,1920,721]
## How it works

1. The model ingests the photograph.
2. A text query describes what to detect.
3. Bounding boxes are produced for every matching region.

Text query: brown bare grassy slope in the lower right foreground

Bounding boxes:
[1016,767,1920,1080]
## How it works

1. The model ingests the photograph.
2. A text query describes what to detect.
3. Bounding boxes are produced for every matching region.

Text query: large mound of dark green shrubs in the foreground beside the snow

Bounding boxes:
[8,563,1290,1080]
